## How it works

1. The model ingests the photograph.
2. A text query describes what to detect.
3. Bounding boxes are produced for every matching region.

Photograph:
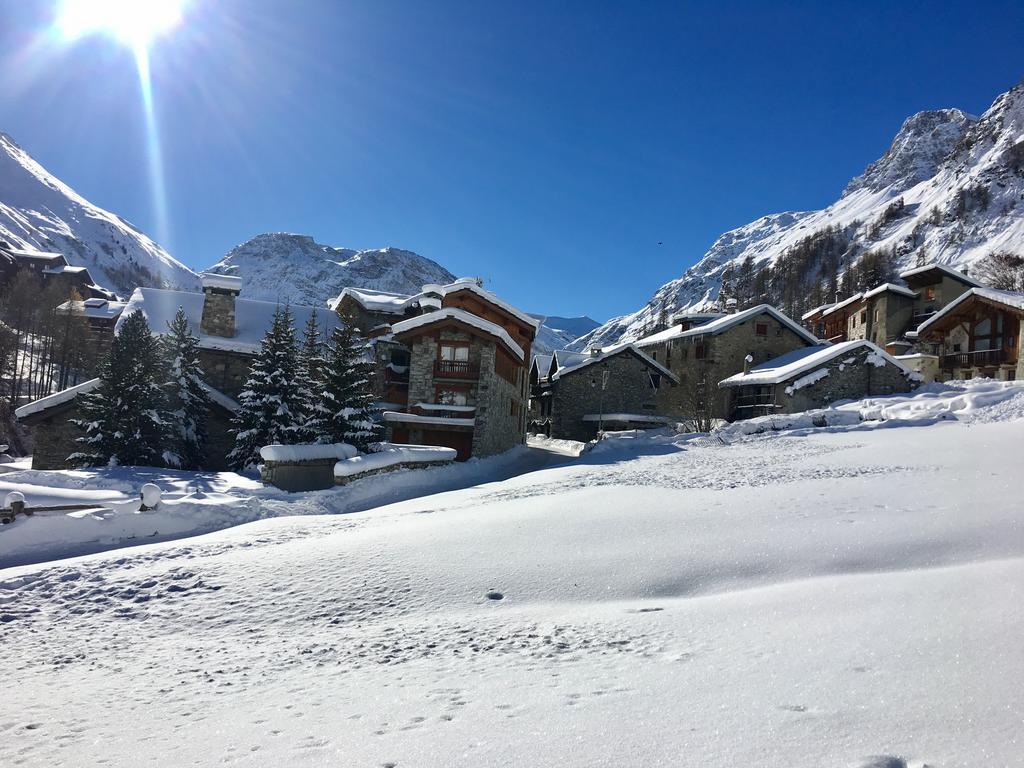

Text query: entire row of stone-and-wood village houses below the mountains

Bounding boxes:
[9,249,1024,469]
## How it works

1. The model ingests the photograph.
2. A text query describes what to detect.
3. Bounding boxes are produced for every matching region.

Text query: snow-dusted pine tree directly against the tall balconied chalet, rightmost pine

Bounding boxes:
[324,309,383,452]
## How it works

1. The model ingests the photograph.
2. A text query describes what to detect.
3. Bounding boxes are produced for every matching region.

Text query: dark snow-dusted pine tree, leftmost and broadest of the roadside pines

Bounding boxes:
[68,311,175,467]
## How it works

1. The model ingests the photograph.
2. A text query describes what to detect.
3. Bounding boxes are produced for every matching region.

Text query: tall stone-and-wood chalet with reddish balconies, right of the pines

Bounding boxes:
[331,279,540,460]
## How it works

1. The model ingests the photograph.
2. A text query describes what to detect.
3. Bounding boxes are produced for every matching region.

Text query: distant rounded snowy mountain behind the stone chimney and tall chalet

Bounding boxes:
[207,232,456,305]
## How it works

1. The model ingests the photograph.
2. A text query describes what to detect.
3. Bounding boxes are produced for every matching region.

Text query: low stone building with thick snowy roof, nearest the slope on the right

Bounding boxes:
[718,339,920,421]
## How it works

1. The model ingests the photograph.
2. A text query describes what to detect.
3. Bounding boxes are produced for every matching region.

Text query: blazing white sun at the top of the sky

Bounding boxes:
[57,0,185,50]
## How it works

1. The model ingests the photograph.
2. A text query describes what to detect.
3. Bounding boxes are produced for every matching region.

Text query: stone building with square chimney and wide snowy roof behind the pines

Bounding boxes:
[14,274,338,469]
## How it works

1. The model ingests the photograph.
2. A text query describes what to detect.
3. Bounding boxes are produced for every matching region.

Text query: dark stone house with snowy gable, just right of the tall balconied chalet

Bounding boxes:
[530,344,678,441]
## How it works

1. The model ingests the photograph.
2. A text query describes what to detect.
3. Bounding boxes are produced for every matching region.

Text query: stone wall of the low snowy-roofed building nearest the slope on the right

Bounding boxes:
[775,349,918,414]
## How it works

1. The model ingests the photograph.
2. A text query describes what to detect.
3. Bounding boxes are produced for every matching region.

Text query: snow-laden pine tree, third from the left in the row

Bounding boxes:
[227,306,303,469]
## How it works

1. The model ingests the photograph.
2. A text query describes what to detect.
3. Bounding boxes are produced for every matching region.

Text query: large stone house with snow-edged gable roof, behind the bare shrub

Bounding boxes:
[636,304,818,421]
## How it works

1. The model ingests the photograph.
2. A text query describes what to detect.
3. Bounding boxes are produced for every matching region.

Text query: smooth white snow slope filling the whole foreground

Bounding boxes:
[0,421,1024,768]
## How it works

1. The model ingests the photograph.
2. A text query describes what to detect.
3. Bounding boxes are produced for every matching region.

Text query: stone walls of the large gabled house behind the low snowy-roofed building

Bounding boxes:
[642,313,808,421]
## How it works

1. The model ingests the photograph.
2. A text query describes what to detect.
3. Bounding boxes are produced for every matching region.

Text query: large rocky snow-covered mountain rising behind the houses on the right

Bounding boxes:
[572,84,1024,349]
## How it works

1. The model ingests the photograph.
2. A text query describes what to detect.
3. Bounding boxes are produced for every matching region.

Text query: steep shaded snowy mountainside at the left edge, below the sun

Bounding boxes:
[0,133,199,294]
